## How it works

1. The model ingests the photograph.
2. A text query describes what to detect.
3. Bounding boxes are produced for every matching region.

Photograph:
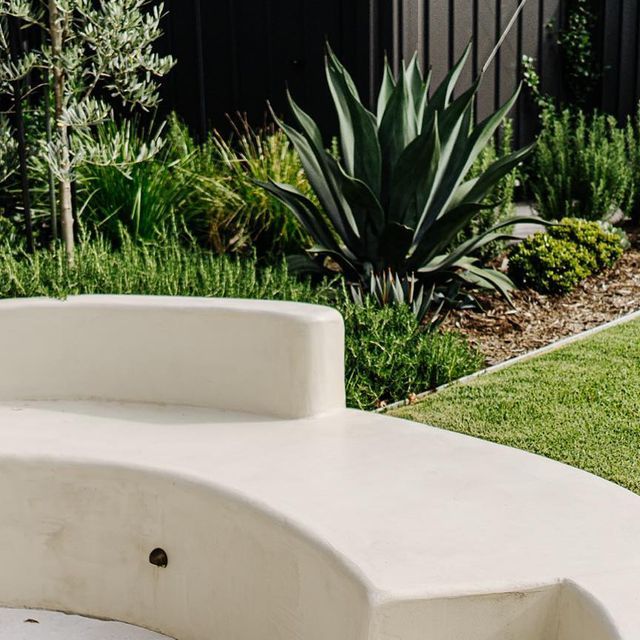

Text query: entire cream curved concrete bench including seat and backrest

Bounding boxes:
[0,297,640,640]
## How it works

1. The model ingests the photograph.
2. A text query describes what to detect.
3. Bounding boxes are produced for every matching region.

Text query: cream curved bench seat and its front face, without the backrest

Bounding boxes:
[0,298,640,640]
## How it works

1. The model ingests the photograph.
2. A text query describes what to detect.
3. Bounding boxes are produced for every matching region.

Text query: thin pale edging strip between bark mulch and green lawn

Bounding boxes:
[375,309,640,413]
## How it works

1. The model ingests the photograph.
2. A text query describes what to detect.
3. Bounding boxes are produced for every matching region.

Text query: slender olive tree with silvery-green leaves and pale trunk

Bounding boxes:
[0,0,174,261]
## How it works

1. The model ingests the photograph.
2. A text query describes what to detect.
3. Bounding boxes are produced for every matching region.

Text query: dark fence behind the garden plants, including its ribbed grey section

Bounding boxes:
[163,0,640,141]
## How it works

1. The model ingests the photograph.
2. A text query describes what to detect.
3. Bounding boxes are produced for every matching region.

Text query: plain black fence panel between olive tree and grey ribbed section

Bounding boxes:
[163,0,375,139]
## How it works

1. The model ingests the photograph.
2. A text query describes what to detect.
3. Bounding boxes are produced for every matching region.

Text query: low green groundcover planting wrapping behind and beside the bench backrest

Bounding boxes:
[0,236,482,409]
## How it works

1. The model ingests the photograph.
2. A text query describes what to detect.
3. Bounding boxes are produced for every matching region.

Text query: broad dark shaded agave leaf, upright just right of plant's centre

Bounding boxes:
[389,116,440,229]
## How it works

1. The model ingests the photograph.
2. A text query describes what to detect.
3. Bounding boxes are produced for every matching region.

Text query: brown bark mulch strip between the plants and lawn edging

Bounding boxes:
[443,250,640,366]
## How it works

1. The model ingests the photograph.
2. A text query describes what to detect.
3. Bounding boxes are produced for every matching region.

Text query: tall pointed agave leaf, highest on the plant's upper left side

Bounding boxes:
[326,48,381,194]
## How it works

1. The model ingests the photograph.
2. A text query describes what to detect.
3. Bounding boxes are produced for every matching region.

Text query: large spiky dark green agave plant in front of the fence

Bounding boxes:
[262,46,531,316]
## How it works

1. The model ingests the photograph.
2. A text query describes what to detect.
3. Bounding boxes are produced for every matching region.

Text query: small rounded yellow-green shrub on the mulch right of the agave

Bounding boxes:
[509,218,623,294]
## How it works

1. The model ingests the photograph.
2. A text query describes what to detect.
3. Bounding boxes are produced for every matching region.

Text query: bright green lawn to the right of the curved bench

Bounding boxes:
[392,321,640,493]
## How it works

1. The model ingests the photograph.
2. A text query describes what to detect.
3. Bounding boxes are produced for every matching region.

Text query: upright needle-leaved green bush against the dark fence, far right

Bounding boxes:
[528,108,635,220]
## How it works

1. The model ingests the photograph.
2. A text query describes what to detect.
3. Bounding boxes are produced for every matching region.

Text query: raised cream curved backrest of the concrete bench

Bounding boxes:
[0,296,344,418]
